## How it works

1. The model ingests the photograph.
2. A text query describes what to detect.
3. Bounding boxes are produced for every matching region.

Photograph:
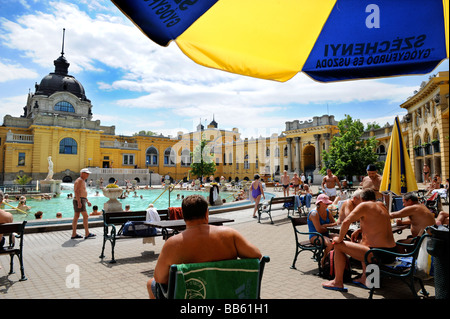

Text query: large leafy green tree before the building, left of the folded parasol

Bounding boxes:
[320,115,380,180]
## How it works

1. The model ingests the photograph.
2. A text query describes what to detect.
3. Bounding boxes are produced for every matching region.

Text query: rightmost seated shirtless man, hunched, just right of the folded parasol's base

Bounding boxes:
[390,193,435,244]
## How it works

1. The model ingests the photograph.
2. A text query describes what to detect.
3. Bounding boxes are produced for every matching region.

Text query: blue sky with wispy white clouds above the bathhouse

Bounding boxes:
[0,0,448,137]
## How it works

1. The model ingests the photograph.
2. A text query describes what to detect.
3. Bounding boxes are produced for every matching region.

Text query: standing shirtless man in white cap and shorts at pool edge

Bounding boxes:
[72,168,95,239]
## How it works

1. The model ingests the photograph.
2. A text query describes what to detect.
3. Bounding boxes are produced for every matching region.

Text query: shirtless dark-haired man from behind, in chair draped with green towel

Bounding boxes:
[147,195,262,299]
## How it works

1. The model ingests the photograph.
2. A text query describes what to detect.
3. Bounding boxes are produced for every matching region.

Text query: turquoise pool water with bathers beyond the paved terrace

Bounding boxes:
[4,183,253,221]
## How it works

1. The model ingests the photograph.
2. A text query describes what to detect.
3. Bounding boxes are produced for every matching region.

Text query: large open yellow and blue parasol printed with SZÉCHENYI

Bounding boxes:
[112,0,449,82]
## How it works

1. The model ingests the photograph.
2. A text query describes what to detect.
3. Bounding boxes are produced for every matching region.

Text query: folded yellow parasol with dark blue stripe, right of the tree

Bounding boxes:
[380,116,418,194]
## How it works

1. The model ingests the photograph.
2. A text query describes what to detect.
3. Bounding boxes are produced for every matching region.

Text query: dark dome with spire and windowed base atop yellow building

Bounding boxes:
[23,30,92,120]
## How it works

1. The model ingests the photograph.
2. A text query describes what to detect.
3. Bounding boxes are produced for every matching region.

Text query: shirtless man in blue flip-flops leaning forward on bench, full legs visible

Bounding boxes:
[322,189,396,292]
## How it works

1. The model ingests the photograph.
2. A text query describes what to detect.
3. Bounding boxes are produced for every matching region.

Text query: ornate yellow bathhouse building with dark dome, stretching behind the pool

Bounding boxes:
[0,50,449,185]
